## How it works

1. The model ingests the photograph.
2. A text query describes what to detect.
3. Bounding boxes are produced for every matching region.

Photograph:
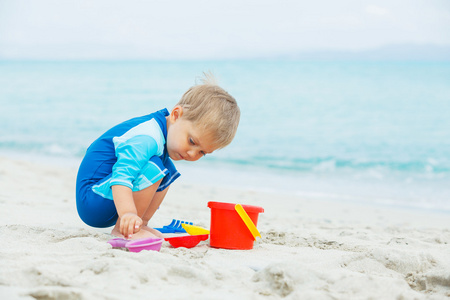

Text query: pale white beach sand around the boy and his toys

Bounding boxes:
[0,157,450,299]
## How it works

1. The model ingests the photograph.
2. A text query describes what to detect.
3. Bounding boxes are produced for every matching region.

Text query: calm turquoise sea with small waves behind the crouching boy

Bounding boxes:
[0,59,450,213]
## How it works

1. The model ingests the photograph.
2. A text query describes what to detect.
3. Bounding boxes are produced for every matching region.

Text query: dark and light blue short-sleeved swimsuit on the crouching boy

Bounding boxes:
[76,109,180,227]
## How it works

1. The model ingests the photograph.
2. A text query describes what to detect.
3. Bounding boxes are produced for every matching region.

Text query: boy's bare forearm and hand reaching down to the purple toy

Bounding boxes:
[111,185,142,238]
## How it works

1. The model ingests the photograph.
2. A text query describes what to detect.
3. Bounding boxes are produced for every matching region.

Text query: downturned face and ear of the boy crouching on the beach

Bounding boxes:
[167,106,217,161]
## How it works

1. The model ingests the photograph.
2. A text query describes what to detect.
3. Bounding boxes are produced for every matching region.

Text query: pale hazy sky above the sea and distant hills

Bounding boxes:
[0,0,450,59]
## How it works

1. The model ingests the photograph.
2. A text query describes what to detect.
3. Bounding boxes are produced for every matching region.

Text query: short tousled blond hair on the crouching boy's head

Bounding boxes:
[177,73,241,149]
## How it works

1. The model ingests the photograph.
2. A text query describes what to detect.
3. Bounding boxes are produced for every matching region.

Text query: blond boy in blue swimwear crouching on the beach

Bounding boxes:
[76,76,240,239]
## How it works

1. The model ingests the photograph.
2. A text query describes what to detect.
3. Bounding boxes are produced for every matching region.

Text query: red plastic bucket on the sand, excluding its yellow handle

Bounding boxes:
[208,202,264,250]
